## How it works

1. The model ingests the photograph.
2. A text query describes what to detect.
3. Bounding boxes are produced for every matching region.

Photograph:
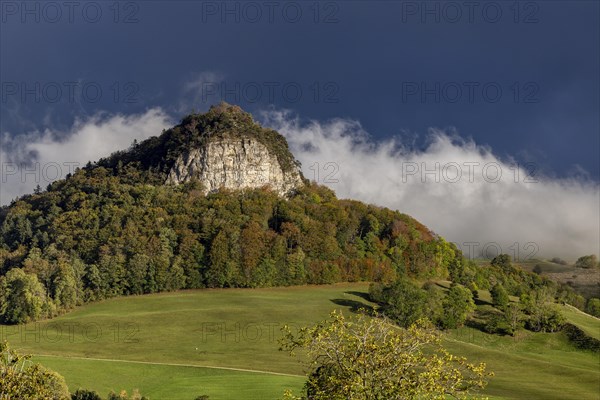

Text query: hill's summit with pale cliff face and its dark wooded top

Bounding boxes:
[99,103,305,196]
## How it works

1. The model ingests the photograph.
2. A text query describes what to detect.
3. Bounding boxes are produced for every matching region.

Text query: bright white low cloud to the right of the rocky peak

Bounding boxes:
[263,111,600,260]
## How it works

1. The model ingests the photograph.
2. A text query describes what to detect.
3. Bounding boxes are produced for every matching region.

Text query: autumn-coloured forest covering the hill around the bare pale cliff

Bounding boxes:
[0,106,463,323]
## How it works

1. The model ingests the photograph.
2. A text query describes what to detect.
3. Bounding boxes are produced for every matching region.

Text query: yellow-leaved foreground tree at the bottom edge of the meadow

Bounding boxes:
[280,312,492,400]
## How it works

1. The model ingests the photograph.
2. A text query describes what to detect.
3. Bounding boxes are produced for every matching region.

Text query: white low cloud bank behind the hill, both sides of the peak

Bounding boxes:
[0,106,600,260]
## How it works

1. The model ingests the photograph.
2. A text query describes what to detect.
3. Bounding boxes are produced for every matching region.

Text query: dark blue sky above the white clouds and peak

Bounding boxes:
[0,0,600,180]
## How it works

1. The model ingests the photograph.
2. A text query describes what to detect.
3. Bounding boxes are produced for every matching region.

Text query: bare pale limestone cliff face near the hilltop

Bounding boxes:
[167,137,303,196]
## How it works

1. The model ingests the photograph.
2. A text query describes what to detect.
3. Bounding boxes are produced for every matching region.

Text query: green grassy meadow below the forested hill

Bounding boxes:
[0,284,600,400]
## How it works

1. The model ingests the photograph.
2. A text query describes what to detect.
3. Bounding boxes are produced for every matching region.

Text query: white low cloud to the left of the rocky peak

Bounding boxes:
[0,108,172,205]
